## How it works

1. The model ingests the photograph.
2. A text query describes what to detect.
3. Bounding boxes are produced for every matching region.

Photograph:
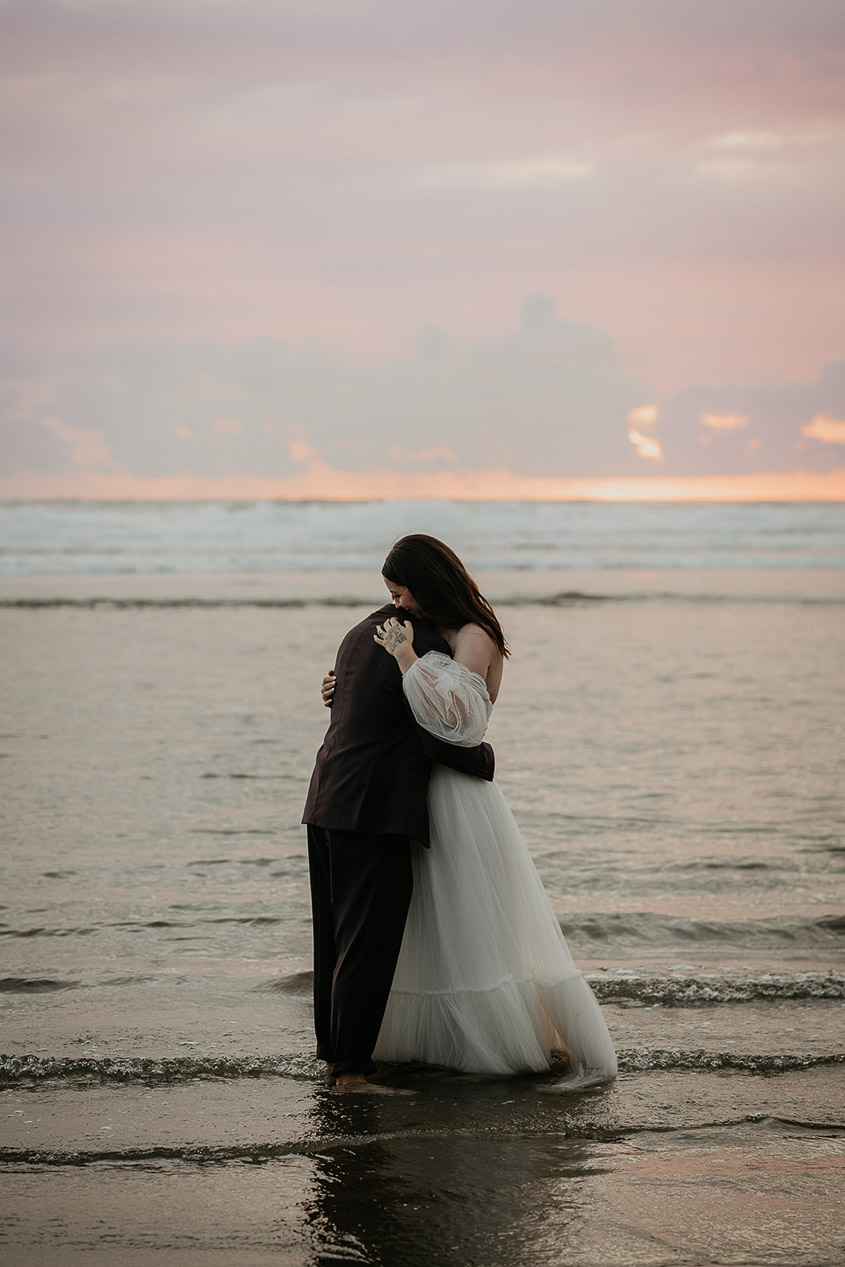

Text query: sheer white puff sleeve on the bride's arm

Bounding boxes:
[402,651,493,748]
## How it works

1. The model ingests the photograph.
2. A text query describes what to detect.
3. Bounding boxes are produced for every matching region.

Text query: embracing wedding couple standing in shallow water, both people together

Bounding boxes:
[303,535,616,1090]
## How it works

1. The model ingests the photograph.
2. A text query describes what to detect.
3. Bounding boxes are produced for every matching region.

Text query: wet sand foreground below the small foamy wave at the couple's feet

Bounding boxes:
[0,1068,845,1267]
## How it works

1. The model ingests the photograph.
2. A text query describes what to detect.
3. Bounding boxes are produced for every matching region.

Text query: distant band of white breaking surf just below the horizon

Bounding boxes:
[0,502,845,576]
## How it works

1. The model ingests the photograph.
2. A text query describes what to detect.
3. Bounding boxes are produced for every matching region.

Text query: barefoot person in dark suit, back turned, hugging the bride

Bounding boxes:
[303,603,494,1086]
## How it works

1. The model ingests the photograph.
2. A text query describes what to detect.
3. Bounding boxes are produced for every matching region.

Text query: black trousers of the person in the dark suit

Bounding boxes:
[308,826,413,1074]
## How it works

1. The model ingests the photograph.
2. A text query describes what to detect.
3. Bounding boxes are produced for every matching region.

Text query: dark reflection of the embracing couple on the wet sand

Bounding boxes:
[303,1087,600,1267]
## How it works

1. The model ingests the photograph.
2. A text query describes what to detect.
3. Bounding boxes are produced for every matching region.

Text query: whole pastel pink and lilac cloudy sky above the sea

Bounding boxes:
[0,0,845,498]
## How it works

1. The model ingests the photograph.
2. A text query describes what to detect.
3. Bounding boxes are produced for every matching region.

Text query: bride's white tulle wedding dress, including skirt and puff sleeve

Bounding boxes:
[374,651,617,1085]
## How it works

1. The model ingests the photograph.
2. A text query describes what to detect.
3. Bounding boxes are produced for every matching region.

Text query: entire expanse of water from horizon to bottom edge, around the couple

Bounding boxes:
[0,502,845,1267]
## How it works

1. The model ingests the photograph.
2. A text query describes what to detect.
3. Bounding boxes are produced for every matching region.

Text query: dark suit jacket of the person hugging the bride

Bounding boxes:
[303,603,495,845]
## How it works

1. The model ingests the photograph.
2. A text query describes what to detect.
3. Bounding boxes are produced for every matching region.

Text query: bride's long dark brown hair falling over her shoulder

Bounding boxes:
[381,532,511,656]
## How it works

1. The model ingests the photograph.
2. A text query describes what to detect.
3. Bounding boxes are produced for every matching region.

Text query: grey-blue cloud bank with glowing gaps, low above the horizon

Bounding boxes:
[0,294,845,497]
